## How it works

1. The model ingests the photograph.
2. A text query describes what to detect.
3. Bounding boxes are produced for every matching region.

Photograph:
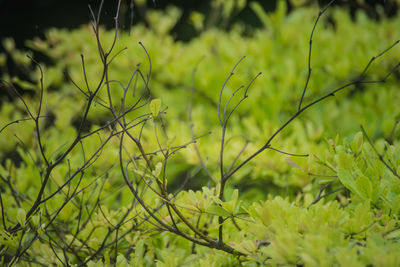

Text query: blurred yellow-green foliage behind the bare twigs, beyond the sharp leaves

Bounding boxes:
[1,0,400,199]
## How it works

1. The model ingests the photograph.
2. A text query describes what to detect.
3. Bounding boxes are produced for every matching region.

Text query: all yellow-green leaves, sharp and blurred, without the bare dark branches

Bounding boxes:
[0,1,400,266]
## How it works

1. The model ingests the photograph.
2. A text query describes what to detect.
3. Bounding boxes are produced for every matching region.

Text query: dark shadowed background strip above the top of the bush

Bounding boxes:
[0,0,399,47]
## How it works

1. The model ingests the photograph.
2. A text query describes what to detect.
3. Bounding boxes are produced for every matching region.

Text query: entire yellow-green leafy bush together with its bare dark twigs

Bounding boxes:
[0,1,400,266]
